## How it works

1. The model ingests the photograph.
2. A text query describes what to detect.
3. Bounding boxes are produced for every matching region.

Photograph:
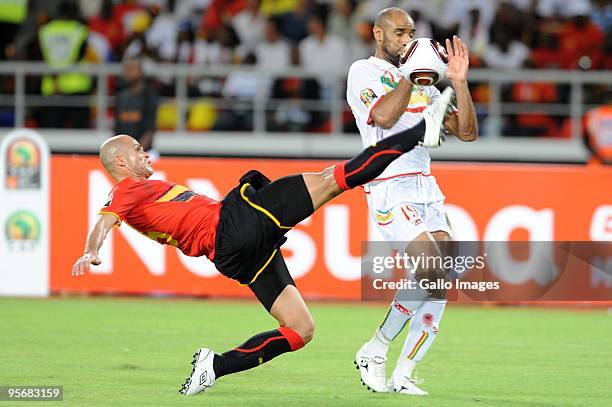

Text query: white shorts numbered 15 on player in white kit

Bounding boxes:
[374,201,453,252]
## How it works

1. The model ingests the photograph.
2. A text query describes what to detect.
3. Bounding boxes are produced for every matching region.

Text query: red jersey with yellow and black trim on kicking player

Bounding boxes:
[100,178,221,260]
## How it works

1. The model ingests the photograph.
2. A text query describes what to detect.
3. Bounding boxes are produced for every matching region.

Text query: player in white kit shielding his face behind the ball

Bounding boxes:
[347,7,478,395]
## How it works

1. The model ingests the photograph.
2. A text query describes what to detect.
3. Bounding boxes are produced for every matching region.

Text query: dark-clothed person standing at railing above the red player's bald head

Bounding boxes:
[114,58,159,159]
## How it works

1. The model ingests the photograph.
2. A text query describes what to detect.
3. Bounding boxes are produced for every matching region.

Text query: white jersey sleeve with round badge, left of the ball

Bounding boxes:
[346,61,386,124]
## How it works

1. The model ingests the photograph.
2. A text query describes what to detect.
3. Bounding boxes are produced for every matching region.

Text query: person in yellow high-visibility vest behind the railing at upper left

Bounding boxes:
[38,2,92,128]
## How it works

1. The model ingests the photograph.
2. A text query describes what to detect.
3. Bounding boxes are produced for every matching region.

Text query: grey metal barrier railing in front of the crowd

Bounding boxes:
[0,62,612,162]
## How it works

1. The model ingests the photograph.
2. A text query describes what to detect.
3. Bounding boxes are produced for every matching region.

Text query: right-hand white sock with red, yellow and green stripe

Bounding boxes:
[394,299,446,377]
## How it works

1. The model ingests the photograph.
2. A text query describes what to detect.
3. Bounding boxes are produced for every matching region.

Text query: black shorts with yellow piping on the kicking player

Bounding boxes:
[214,171,313,310]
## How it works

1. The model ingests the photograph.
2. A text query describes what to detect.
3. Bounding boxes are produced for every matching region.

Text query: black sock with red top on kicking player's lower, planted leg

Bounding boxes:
[213,327,304,379]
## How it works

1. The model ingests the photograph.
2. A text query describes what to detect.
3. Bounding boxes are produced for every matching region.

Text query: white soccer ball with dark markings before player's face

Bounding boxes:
[400,38,448,86]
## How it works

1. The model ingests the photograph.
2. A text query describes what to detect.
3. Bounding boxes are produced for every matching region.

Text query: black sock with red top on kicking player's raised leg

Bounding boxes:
[334,120,425,190]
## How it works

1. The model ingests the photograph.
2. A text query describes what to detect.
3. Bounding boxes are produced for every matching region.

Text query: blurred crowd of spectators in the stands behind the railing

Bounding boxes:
[0,0,612,137]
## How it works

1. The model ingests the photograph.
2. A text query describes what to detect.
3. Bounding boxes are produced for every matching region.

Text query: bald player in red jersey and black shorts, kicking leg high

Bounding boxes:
[72,88,452,394]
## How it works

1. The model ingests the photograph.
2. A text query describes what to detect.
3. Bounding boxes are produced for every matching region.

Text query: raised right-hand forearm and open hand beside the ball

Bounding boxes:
[444,36,478,141]
